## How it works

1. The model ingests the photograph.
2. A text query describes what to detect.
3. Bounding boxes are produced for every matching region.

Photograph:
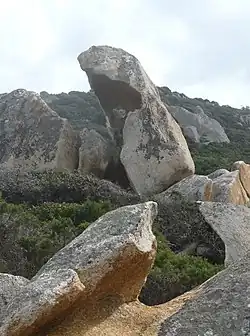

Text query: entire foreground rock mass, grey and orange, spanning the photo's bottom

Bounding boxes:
[0,198,250,336]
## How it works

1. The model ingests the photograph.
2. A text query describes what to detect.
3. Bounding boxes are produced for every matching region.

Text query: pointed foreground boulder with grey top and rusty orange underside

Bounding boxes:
[0,202,157,336]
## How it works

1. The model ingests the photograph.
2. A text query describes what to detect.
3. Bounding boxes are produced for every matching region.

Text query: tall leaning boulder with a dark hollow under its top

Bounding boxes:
[78,46,194,195]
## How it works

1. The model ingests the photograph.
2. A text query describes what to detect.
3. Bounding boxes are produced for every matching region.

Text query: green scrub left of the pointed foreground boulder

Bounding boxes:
[0,200,112,278]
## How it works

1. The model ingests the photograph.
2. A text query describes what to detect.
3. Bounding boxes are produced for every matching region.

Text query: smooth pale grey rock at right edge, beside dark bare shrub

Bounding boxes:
[199,202,250,265]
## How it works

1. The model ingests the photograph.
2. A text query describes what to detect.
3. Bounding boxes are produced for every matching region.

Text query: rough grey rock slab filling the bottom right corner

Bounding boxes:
[156,252,250,336]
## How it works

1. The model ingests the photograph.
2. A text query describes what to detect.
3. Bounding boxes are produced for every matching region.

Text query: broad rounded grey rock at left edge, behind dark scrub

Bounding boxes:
[0,89,78,171]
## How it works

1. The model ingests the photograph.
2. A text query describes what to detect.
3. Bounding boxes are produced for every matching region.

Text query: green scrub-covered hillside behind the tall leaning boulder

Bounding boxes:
[41,87,250,175]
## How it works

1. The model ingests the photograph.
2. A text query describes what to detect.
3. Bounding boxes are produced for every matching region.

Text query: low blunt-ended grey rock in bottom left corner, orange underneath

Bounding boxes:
[0,269,85,336]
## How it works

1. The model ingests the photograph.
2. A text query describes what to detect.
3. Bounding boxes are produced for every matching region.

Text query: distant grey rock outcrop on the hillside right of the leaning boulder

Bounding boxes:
[169,106,230,143]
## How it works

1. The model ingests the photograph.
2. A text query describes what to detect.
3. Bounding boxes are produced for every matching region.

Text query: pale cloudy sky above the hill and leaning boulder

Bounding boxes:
[0,0,250,107]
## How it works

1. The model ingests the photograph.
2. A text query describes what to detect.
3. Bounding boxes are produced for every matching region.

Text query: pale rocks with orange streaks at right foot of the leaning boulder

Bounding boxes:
[152,167,250,205]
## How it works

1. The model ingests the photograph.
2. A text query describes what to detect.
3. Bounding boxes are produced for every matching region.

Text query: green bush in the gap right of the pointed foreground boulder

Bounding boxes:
[140,231,223,305]
